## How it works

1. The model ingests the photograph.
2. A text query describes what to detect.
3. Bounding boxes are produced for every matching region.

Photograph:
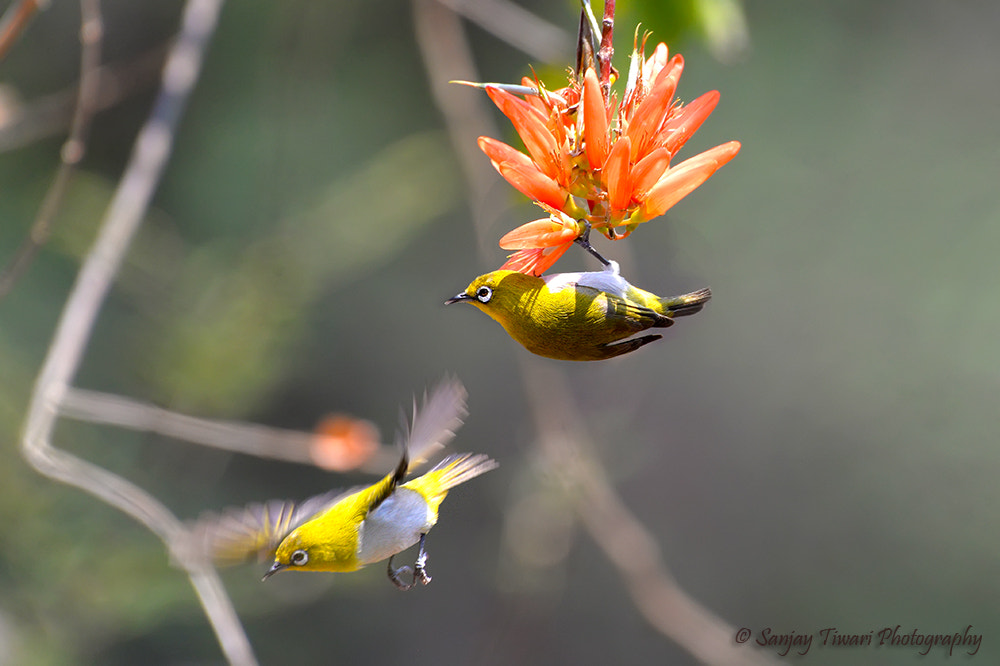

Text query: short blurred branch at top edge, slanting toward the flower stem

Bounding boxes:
[438,0,572,64]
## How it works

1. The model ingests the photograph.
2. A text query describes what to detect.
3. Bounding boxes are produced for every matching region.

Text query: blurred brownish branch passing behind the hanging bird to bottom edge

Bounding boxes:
[413,0,772,666]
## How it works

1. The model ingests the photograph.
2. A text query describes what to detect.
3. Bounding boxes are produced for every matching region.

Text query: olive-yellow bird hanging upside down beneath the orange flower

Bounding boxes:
[445,259,712,361]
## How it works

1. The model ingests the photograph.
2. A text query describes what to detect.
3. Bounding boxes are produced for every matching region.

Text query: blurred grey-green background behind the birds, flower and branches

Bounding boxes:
[0,0,1000,666]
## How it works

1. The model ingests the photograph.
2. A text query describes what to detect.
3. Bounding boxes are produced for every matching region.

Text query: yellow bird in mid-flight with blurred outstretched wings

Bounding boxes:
[190,381,498,590]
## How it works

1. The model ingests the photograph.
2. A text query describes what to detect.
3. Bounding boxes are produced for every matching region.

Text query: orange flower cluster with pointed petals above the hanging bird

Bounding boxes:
[479,40,740,275]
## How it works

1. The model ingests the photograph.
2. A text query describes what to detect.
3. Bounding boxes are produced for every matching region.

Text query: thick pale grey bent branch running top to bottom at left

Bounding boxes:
[22,0,256,664]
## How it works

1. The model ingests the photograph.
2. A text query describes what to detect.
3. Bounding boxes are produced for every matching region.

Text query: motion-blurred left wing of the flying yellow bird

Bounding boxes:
[188,489,356,566]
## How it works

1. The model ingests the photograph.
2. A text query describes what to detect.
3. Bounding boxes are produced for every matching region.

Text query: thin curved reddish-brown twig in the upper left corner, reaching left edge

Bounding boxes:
[0,0,104,298]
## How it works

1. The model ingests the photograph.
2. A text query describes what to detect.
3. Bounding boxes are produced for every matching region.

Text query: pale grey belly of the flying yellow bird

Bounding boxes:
[358,488,431,564]
